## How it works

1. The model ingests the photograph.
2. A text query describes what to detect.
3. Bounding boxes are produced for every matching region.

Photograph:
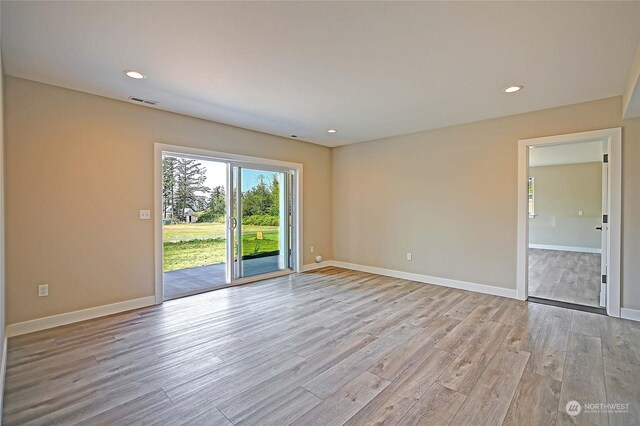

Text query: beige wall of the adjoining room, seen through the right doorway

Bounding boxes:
[529,162,602,249]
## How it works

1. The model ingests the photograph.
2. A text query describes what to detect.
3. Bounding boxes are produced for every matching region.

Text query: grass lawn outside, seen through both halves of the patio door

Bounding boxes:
[163,223,279,272]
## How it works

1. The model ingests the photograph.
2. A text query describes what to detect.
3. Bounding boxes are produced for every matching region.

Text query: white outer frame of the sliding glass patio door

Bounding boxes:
[152,143,304,305]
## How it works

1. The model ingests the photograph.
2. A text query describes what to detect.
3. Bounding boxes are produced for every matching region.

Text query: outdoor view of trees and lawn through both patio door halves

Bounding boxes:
[162,156,280,272]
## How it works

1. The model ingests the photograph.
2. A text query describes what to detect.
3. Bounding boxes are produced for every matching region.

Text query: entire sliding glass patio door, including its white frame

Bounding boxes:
[155,144,302,303]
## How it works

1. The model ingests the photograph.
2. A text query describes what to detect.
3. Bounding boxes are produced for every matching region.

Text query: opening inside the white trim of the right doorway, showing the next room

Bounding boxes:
[528,140,608,308]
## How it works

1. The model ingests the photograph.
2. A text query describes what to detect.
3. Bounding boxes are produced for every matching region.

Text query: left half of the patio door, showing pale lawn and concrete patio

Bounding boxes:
[162,154,228,300]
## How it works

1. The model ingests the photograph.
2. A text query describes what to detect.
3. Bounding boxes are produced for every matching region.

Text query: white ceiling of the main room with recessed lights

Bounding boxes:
[1,1,640,146]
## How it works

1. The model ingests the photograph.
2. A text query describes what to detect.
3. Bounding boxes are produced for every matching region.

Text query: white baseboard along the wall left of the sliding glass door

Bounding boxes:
[6,296,156,337]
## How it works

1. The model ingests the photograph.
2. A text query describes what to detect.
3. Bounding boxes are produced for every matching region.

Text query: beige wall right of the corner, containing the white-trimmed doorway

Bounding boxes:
[333,97,640,309]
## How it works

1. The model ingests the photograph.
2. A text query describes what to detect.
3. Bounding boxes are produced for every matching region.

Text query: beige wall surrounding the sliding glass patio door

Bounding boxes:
[5,77,332,324]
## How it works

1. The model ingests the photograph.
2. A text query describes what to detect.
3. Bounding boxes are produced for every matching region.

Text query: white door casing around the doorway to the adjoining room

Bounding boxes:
[516,127,622,317]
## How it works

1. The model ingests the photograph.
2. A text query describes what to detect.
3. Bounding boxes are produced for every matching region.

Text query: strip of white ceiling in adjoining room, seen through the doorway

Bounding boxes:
[529,140,603,167]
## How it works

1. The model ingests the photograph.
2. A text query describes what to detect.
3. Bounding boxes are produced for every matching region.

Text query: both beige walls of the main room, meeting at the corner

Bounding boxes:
[5,77,640,324]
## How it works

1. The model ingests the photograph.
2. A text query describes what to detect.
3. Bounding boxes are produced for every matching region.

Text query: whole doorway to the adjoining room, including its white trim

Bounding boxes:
[517,128,622,317]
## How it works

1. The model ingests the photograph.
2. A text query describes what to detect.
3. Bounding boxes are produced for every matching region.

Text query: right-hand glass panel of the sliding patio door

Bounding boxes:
[229,164,293,281]
